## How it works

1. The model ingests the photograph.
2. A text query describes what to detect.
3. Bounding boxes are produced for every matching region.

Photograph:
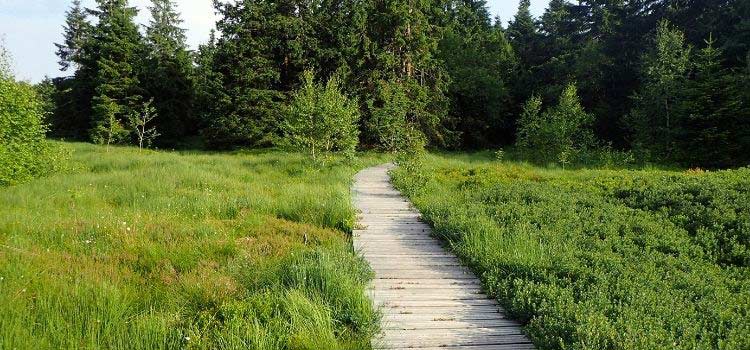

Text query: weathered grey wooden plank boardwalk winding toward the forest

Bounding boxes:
[353,165,534,350]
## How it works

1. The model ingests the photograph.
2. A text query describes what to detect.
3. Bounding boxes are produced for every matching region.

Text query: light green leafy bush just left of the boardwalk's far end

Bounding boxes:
[282,71,359,160]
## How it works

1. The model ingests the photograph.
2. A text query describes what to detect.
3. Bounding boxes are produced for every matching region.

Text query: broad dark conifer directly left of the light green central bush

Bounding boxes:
[203,0,292,148]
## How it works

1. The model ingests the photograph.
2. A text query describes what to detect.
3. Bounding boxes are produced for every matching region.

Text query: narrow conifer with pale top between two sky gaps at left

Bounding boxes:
[141,0,197,145]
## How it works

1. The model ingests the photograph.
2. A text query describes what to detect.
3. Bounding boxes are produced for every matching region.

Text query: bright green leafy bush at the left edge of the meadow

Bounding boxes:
[0,46,64,186]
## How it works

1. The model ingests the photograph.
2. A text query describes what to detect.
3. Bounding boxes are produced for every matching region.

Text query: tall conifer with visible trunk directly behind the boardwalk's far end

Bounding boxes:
[364,0,453,149]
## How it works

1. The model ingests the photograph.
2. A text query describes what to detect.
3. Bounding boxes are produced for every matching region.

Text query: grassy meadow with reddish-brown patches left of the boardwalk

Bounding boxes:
[0,144,388,349]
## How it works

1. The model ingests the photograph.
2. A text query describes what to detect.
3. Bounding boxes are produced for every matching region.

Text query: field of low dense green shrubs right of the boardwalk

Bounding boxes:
[395,155,750,350]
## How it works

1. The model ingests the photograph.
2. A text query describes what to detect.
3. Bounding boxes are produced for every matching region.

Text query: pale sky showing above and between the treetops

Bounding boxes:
[0,0,549,82]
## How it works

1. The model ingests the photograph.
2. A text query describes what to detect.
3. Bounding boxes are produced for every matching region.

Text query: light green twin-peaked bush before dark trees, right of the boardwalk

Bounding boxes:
[517,84,595,166]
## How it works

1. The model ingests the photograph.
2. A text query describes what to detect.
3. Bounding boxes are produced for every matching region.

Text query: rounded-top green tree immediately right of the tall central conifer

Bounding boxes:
[439,0,516,148]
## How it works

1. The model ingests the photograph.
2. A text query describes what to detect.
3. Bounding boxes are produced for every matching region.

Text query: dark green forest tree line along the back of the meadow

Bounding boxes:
[38,0,750,167]
